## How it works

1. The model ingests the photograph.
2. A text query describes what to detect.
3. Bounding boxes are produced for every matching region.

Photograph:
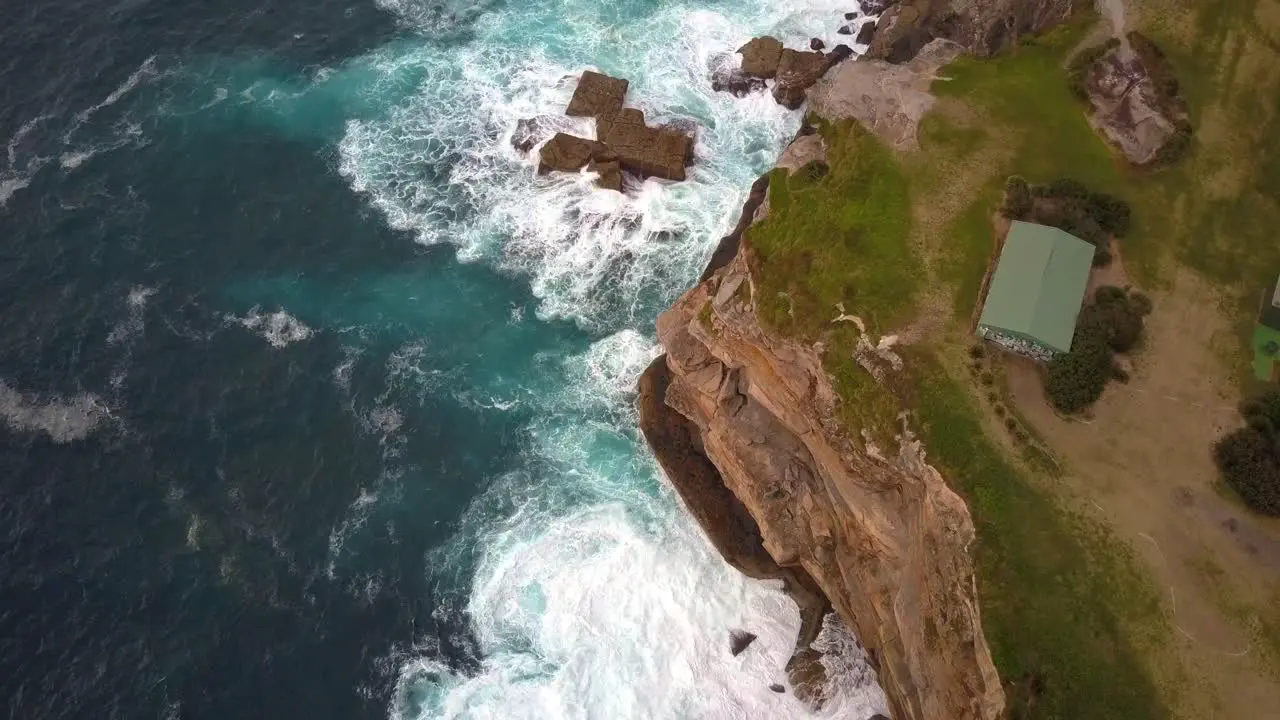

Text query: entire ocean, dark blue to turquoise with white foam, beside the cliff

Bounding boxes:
[0,0,884,720]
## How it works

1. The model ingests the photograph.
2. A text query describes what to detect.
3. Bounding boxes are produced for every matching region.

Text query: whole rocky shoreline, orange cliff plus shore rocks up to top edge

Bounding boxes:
[639,0,1070,720]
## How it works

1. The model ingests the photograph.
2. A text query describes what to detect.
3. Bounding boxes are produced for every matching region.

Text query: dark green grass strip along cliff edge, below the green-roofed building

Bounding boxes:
[911,356,1169,720]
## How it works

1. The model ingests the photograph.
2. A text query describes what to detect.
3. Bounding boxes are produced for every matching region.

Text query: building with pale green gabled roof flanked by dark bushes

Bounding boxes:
[978,220,1093,360]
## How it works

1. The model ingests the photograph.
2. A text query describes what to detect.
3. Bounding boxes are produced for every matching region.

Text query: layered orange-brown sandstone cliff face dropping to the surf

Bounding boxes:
[640,215,1005,720]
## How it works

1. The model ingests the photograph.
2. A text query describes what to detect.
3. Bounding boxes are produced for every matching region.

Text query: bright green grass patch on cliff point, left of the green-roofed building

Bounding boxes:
[746,122,920,442]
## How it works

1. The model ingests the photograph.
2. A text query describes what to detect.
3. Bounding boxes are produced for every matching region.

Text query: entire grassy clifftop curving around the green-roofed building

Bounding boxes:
[748,0,1280,720]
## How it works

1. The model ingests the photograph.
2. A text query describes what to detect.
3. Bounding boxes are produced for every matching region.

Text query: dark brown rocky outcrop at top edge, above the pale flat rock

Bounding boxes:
[867,0,1071,63]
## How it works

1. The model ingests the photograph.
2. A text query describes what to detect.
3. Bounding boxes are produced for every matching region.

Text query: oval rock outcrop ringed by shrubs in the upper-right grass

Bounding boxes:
[1085,33,1190,165]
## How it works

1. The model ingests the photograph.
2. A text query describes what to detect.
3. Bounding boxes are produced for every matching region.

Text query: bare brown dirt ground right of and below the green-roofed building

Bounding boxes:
[1006,272,1280,719]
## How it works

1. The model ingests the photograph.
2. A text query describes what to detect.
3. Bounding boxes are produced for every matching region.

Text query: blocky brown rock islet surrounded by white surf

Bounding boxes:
[529,70,694,185]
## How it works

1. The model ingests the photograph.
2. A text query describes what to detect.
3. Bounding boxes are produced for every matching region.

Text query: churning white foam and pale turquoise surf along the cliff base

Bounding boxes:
[339,0,884,707]
